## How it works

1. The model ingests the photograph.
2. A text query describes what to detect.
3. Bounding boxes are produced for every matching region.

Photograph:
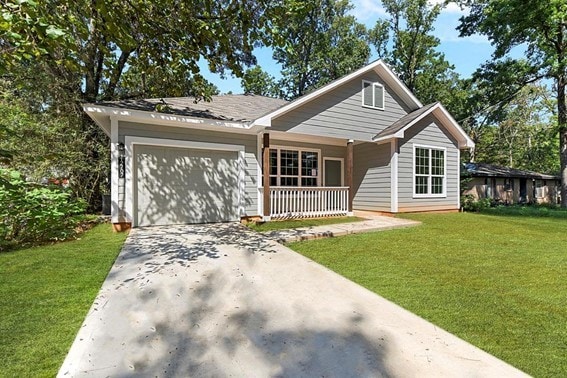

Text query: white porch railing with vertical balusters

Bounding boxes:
[270,186,349,219]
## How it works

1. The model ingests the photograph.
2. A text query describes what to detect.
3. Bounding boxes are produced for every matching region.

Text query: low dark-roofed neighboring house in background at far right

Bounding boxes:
[463,163,561,204]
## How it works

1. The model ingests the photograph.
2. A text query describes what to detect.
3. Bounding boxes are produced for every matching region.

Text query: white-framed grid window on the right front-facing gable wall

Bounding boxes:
[413,146,446,197]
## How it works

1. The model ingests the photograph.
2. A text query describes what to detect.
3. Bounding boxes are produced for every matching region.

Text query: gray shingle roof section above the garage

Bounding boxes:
[98,94,287,122]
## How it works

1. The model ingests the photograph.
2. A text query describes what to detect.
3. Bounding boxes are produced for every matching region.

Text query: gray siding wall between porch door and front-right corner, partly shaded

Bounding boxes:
[353,143,391,212]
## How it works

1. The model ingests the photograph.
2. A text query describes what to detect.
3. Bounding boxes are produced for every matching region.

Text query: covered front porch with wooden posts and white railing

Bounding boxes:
[259,133,353,221]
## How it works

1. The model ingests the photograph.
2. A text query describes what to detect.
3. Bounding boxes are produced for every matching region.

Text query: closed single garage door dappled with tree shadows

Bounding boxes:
[134,145,239,226]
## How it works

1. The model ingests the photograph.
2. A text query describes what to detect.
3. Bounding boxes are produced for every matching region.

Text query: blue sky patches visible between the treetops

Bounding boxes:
[199,0,494,93]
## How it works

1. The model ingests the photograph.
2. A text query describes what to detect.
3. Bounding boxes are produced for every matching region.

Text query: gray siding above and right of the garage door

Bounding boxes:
[118,122,258,216]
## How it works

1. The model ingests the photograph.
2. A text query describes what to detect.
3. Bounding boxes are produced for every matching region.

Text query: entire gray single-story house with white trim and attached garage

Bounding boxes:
[84,60,474,227]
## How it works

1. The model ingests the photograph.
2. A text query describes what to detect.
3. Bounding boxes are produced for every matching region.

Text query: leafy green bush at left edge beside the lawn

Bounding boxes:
[0,168,86,251]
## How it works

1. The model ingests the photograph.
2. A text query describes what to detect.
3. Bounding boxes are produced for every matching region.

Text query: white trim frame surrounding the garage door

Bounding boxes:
[124,136,245,227]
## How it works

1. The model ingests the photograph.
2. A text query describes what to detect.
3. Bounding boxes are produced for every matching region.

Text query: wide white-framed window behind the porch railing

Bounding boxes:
[270,147,319,186]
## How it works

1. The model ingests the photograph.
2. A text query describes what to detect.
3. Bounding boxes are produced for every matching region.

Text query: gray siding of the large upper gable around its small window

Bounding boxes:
[272,72,409,141]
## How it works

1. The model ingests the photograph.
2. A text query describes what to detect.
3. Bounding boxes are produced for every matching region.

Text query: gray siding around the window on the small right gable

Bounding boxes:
[398,116,459,212]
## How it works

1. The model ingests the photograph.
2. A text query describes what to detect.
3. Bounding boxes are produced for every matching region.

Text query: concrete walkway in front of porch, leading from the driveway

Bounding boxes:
[262,211,421,243]
